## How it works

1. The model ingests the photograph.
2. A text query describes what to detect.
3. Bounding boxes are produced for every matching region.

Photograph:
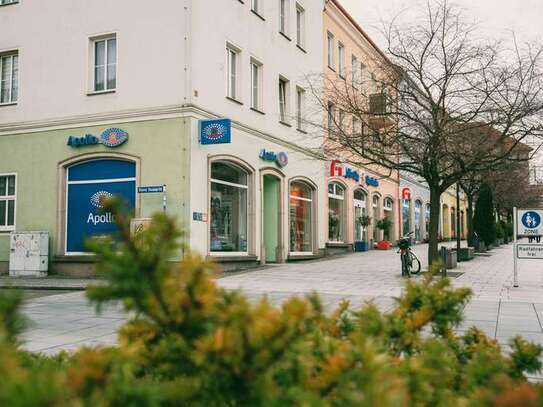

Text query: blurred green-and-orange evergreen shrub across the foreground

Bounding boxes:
[0,202,543,406]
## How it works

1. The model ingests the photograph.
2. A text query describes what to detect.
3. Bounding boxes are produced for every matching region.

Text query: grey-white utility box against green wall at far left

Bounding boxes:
[9,232,49,277]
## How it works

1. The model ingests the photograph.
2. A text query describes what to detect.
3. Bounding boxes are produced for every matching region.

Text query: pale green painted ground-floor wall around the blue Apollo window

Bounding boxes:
[0,118,190,261]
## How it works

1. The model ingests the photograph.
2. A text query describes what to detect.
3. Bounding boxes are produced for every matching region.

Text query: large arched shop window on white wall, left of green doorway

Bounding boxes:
[209,161,249,253]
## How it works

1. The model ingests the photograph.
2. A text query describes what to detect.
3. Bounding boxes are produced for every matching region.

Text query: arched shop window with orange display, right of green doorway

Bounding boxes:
[289,181,313,253]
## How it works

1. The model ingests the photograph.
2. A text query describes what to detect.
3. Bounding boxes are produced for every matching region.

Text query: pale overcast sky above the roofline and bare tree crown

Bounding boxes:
[340,0,543,45]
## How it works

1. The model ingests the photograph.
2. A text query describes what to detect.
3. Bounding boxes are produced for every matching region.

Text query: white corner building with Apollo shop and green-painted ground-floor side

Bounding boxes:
[0,0,327,274]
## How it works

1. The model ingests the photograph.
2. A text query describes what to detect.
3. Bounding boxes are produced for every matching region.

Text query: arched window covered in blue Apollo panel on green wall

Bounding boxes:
[65,158,136,254]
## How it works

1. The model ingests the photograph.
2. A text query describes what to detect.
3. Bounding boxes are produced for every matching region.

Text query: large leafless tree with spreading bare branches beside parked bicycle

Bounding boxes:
[311,1,543,262]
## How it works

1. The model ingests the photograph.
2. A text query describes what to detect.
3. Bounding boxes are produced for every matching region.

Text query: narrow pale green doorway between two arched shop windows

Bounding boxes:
[262,175,281,263]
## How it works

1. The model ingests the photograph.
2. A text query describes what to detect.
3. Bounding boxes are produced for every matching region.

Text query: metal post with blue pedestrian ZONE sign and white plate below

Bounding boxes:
[513,207,543,287]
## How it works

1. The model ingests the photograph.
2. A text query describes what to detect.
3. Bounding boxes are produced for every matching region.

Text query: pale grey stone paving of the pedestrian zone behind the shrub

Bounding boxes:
[20,245,543,372]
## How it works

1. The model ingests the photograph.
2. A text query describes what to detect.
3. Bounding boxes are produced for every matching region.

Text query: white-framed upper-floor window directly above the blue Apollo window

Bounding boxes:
[93,37,117,92]
